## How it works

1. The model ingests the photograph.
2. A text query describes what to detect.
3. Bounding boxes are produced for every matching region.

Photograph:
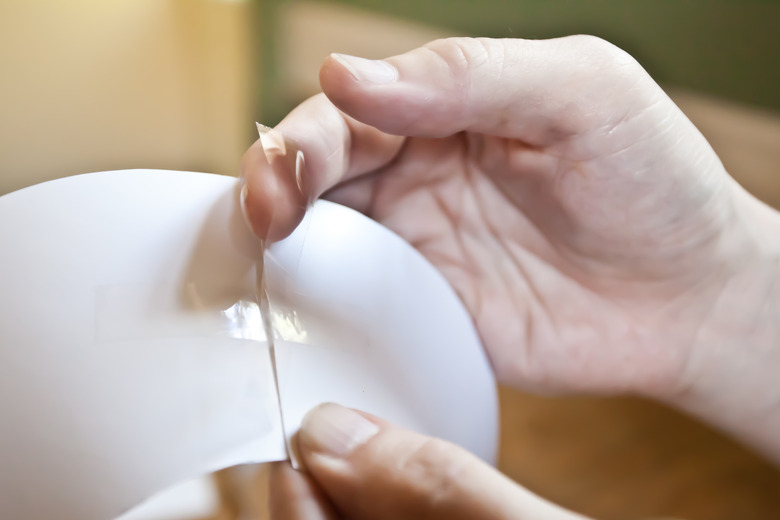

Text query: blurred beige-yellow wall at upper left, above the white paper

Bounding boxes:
[0,0,254,194]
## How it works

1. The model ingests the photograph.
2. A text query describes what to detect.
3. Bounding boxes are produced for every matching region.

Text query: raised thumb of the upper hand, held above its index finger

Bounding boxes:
[320,36,660,146]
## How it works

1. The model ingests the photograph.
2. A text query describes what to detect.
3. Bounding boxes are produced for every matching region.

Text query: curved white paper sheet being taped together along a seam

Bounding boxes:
[0,170,496,520]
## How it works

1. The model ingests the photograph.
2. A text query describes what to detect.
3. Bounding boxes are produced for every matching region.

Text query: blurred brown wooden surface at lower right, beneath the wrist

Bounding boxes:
[499,389,780,520]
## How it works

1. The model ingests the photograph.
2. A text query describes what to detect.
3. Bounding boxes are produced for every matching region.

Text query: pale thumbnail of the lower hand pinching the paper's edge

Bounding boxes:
[298,403,379,458]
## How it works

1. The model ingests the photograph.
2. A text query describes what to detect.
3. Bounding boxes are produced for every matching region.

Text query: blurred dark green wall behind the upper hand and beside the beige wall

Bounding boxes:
[255,0,780,121]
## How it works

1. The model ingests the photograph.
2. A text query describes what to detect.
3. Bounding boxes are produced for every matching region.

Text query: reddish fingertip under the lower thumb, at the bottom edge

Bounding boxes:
[268,462,338,520]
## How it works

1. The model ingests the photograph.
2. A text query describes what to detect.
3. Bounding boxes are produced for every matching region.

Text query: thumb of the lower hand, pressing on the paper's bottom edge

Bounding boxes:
[298,404,583,520]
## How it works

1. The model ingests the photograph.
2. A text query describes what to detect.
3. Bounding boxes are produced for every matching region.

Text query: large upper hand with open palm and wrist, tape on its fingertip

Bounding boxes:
[243,36,780,460]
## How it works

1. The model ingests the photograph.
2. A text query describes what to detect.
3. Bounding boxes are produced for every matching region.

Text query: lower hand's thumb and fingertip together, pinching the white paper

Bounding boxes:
[269,404,585,520]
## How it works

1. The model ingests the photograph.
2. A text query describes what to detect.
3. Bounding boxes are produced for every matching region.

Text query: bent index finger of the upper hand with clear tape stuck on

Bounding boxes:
[242,95,403,241]
